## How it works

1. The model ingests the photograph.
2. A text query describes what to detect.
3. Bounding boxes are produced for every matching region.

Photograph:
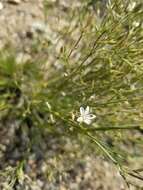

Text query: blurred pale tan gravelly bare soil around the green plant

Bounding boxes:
[0,0,142,190]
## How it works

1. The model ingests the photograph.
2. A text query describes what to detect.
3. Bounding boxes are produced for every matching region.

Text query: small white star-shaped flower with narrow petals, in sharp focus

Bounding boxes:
[77,106,96,125]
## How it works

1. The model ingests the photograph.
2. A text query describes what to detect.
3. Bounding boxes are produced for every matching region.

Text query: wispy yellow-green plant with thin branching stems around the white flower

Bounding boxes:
[0,0,143,188]
